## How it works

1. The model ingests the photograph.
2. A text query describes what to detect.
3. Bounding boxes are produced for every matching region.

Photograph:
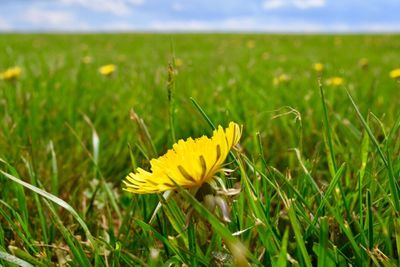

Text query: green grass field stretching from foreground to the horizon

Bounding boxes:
[0,34,400,266]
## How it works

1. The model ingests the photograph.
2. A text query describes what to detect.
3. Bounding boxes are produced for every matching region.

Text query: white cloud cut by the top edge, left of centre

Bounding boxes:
[58,0,144,16]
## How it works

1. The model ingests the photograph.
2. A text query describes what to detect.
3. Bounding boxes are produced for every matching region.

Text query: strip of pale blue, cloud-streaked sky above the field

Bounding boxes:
[0,0,400,33]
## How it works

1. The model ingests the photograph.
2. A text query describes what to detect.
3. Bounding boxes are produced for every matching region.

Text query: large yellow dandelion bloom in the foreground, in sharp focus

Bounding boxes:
[124,122,241,194]
